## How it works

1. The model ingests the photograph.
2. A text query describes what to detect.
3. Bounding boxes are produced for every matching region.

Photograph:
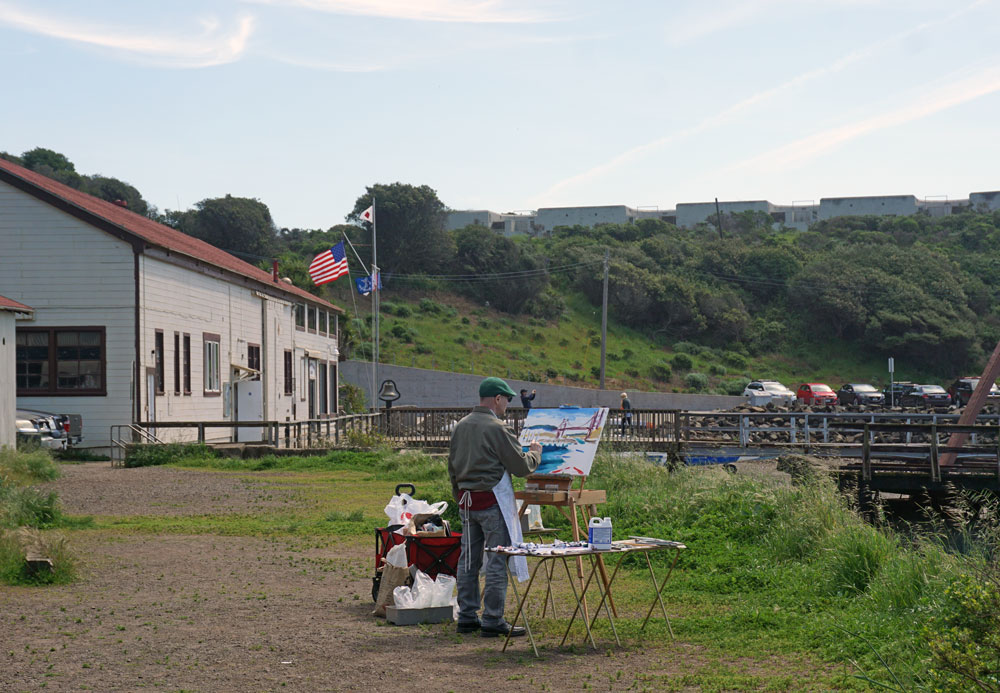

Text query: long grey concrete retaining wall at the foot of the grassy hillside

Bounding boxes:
[340,361,744,411]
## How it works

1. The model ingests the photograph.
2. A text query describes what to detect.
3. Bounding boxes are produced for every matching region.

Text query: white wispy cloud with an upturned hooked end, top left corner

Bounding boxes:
[0,3,254,67]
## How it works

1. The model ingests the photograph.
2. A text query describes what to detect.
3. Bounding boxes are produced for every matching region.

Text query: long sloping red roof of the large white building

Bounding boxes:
[0,158,344,313]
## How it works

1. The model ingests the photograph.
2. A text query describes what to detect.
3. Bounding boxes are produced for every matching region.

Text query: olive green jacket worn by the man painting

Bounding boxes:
[448,407,542,500]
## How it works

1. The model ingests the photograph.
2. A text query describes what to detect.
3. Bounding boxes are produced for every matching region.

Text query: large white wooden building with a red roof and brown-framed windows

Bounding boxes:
[0,159,343,448]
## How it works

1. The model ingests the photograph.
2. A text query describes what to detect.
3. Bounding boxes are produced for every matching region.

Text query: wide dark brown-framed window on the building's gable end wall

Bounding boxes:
[15,327,107,395]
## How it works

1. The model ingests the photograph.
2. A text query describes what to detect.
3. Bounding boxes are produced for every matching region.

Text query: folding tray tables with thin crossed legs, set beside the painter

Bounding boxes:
[486,538,687,657]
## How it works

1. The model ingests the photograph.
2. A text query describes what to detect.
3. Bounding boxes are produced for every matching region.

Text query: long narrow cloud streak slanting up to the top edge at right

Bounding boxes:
[534,0,987,202]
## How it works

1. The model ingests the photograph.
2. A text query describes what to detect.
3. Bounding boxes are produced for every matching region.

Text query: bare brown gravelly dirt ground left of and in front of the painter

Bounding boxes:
[0,463,800,693]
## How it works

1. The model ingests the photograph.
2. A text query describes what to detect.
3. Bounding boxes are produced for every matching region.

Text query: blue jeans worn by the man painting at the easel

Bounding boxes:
[458,505,510,628]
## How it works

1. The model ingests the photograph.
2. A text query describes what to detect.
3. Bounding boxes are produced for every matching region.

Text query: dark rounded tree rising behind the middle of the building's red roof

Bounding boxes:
[174,195,277,257]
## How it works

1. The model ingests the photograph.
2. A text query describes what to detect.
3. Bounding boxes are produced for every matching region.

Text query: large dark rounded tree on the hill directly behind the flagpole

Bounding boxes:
[347,183,455,274]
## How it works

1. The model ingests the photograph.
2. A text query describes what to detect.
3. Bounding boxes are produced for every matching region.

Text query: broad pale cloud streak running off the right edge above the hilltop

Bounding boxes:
[724,66,1000,172]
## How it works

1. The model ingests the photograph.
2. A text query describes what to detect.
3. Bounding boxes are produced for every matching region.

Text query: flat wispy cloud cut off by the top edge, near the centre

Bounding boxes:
[251,0,554,24]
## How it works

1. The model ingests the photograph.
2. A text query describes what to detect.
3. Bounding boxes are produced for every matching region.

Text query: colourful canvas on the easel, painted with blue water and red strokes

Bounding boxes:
[518,407,608,476]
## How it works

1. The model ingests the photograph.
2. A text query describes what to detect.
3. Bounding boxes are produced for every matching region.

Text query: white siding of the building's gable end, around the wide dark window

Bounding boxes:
[0,182,135,447]
